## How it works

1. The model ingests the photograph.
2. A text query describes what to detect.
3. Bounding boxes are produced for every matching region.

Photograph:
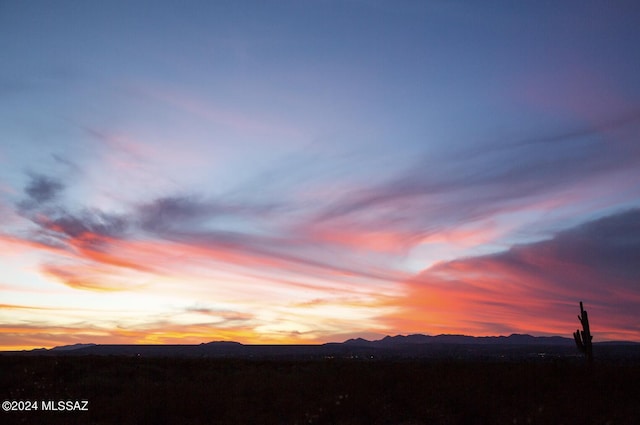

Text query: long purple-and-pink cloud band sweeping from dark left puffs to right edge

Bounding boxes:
[23,105,640,292]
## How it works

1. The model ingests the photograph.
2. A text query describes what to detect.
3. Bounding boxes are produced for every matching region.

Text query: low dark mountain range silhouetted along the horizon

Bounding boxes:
[0,334,640,359]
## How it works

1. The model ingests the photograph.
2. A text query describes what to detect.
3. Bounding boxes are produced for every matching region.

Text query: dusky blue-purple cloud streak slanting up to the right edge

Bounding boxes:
[319,114,640,224]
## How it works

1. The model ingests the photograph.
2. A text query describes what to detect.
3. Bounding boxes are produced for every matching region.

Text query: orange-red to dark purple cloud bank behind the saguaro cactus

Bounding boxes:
[389,209,640,340]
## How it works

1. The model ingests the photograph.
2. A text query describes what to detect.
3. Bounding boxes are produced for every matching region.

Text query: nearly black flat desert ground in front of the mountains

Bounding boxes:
[0,356,640,425]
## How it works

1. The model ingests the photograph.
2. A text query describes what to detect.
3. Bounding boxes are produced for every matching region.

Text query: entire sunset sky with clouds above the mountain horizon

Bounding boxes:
[0,0,640,350]
